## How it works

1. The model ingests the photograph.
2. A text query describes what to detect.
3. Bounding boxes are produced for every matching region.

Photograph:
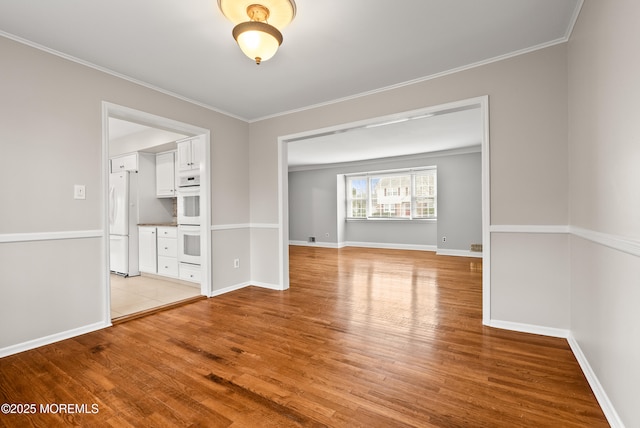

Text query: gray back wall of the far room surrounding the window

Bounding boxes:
[289,152,482,252]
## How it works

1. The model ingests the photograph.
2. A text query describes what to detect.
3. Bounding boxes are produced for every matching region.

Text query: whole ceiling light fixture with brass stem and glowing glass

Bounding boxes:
[218,0,296,64]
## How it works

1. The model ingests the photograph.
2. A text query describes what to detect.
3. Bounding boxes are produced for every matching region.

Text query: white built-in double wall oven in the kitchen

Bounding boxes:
[177,174,201,267]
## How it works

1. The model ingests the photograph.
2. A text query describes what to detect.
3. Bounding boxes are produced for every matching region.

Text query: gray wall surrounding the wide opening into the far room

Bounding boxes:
[250,44,569,318]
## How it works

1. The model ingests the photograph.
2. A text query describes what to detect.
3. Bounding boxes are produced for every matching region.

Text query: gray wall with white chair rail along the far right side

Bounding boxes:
[568,0,640,427]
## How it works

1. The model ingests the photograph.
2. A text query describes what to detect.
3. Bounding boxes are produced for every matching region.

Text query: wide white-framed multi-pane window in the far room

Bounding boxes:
[347,167,437,219]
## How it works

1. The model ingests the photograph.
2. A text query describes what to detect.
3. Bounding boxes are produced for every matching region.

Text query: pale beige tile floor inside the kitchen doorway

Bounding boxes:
[111,274,200,319]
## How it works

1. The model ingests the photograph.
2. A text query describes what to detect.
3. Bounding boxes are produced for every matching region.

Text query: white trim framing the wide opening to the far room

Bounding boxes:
[278,96,491,324]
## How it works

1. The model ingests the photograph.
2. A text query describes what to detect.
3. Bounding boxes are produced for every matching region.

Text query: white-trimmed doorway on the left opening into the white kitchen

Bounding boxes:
[102,102,211,320]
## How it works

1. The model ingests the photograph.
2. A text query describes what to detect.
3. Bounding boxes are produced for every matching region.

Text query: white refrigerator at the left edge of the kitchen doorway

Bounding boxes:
[109,171,140,276]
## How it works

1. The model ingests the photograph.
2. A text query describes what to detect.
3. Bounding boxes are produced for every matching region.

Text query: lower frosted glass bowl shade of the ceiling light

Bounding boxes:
[233,21,282,64]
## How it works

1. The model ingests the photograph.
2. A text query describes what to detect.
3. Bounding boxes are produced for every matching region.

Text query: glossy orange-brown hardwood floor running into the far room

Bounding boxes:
[0,247,608,427]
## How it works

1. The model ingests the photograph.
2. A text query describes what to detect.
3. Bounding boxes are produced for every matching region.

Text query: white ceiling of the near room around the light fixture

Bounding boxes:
[0,0,582,121]
